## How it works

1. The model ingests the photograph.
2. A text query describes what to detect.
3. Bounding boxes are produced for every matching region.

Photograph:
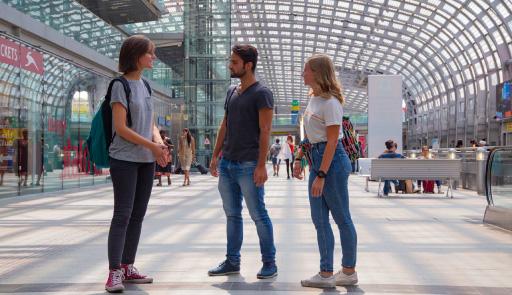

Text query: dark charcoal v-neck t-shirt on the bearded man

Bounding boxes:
[222,82,274,162]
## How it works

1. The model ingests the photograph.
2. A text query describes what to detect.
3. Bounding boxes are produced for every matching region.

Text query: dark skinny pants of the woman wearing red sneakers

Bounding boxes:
[108,158,155,269]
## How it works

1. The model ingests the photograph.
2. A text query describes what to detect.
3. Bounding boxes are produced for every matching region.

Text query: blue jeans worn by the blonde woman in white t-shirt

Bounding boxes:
[309,142,357,272]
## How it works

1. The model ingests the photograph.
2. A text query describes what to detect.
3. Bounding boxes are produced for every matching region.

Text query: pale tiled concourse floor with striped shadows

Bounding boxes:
[0,168,512,295]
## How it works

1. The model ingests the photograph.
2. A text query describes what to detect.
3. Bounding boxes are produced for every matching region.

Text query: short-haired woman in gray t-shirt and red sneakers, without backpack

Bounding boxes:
[105,35,168,292]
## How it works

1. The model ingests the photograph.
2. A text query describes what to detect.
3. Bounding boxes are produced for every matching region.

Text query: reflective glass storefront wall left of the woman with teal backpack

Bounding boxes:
[0,35,109,197]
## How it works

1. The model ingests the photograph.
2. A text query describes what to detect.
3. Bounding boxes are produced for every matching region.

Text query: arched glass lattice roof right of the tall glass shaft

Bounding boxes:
[232,0,512,113]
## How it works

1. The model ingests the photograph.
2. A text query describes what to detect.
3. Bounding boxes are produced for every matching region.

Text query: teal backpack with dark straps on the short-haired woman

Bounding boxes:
[84,76,151,168]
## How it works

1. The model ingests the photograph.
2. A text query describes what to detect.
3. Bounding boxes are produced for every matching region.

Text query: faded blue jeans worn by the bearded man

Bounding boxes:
[219,159,276,265]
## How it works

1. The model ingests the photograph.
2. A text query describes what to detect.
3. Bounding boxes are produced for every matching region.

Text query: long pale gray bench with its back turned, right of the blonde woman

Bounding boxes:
[370,159,461,198]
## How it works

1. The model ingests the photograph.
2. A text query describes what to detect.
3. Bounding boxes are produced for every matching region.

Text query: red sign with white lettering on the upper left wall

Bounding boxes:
[0,37,44,75]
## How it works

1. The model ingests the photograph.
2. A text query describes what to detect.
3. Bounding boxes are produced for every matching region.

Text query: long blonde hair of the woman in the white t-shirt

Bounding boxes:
[306,54,345,104]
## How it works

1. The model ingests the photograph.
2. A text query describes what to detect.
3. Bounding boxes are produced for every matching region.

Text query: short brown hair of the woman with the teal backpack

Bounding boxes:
[119,35,154,74]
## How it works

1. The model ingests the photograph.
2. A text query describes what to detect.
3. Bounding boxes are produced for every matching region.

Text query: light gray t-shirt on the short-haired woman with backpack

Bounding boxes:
[110,80,155,163]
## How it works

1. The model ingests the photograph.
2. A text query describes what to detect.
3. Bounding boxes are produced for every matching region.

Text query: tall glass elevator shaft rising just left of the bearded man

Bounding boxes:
[184,0,231,165]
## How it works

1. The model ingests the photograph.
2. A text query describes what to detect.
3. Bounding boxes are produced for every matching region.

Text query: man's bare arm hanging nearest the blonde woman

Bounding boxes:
[254,108,274,186]
